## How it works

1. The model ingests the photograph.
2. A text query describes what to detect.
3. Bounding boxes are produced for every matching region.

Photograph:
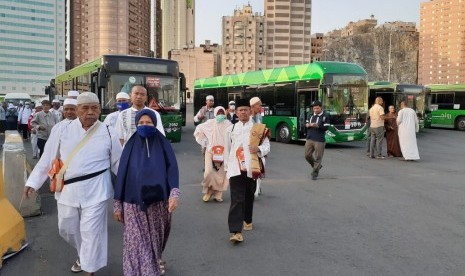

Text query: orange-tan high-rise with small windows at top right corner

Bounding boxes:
[418,0,465,84]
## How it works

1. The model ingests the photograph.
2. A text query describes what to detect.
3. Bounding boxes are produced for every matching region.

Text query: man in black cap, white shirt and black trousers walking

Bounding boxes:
[224,99,270,243]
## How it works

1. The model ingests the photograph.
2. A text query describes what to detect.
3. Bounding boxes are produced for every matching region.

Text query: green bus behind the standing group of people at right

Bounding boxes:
[368,81,431,128]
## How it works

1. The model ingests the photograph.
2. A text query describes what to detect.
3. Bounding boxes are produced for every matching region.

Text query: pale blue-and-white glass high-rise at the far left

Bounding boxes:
[0,0,65,95]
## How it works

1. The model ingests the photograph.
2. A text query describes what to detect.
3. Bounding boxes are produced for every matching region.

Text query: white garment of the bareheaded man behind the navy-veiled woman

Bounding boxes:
[115,107,166,144]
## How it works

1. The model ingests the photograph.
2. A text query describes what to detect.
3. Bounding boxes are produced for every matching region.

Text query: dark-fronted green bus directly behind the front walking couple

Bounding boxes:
[46,55,186,142]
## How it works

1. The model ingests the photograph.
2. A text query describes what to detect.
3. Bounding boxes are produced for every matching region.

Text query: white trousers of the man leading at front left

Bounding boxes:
[57,201,108,272]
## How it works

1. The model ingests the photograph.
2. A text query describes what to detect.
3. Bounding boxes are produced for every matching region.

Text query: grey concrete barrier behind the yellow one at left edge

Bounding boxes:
[3,131,41,217]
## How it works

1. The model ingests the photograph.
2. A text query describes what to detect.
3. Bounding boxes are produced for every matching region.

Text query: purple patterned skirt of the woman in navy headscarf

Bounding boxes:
[123,201,171,276]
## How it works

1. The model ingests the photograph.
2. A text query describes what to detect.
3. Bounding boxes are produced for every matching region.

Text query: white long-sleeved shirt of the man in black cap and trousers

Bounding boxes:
[224,120,270,178]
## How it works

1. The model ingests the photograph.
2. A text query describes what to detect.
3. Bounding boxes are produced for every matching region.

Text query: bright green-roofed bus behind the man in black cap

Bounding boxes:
[194,62,368,143]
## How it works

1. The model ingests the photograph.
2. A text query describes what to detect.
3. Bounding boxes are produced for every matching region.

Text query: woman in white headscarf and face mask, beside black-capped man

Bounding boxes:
[194,106,231,202]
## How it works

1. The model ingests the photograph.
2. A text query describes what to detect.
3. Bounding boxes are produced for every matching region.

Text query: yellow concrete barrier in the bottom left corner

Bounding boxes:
[0,160,27,268]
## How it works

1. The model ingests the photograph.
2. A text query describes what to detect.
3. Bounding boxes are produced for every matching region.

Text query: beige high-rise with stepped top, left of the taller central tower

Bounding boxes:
[221,4,266,75]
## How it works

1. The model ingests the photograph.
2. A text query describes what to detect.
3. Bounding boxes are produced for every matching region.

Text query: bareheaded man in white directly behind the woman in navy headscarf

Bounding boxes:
[116,85,165,146]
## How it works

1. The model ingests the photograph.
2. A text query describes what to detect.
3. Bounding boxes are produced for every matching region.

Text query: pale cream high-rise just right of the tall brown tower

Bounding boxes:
[161,0,195,58]
